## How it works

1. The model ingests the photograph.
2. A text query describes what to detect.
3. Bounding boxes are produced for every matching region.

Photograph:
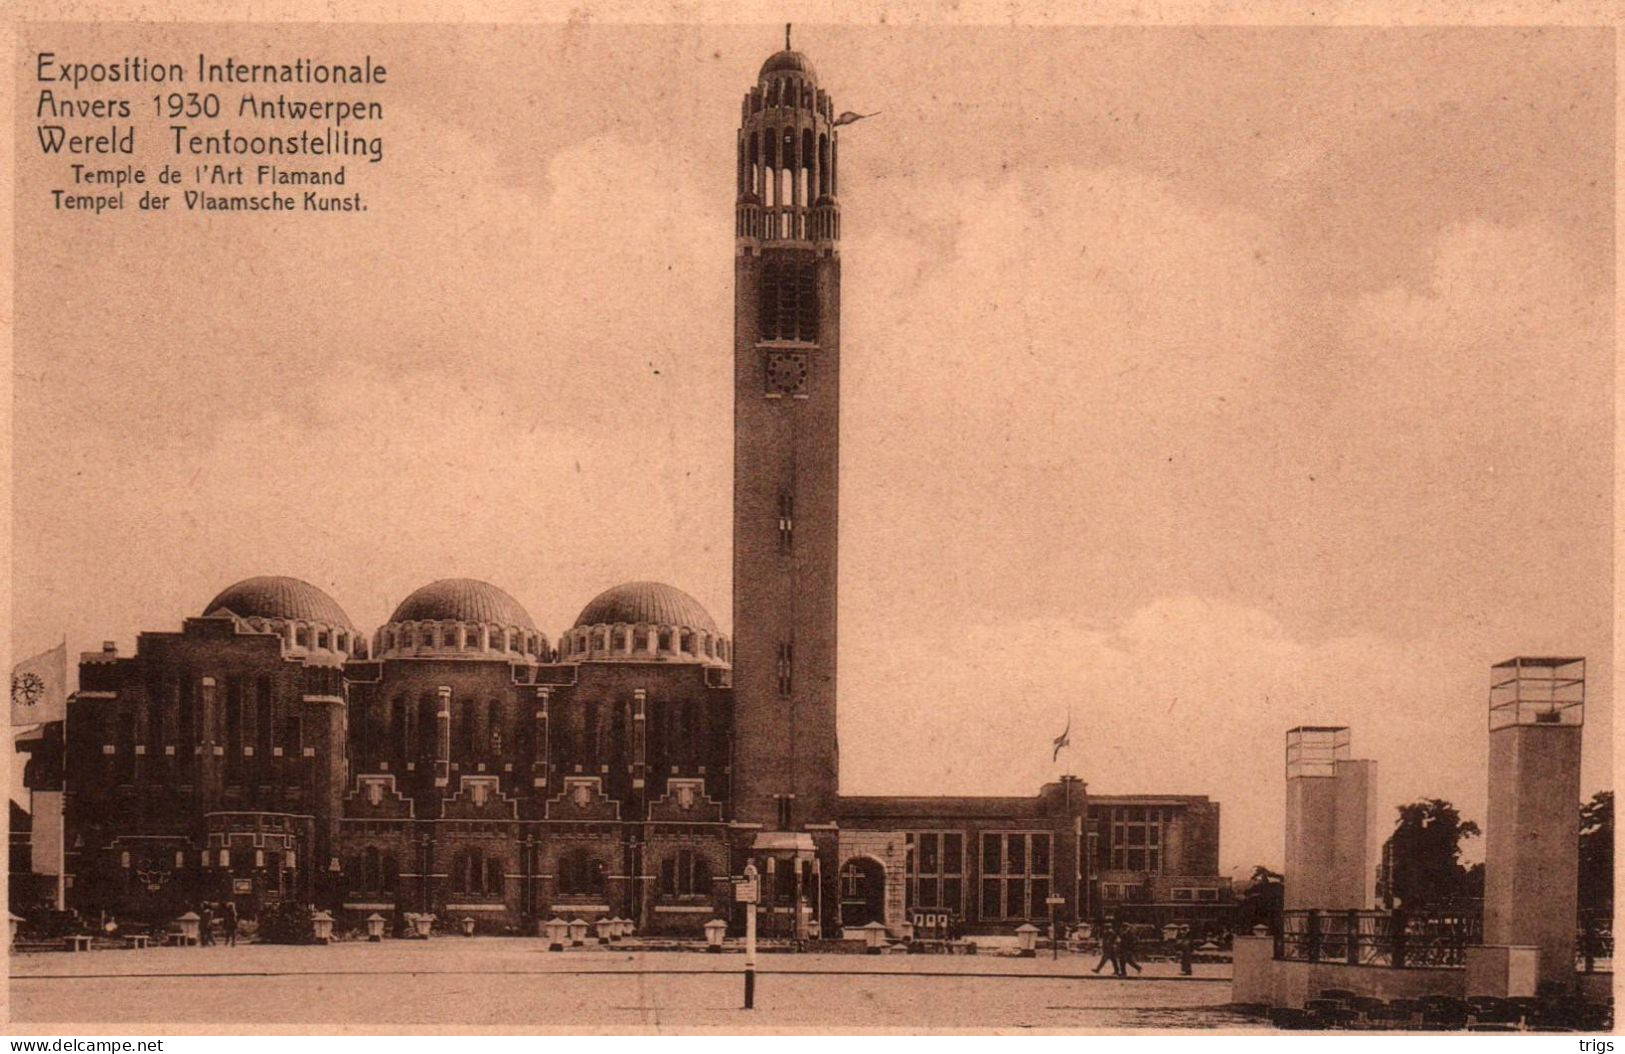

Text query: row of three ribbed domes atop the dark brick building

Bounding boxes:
[203,577,733,664]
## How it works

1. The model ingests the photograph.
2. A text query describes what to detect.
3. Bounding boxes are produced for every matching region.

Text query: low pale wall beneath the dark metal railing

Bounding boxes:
[1232,937,1467,1007]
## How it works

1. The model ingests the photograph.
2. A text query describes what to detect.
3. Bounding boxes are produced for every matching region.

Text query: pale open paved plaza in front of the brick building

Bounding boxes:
[10,937,1268,1031]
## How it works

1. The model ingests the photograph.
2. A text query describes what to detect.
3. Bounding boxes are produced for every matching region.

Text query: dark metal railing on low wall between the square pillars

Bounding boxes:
[1276,909,1484,968]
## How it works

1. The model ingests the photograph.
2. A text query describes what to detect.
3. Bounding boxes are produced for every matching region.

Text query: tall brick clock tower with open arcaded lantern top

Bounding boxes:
[733,29,840,830]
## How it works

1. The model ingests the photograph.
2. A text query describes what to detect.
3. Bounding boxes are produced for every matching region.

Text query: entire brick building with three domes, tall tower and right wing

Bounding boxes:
[41,36,1227,934]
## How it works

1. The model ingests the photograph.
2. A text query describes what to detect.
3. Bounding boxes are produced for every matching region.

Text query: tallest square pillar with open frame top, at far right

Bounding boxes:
[1484,656,1586,987]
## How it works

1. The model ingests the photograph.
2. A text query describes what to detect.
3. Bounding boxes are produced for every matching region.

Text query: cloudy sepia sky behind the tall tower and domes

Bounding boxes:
[11,24,1614,870]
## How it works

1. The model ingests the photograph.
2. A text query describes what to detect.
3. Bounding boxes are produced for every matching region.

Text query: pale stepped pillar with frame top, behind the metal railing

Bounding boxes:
[1285,724,1376,911]
